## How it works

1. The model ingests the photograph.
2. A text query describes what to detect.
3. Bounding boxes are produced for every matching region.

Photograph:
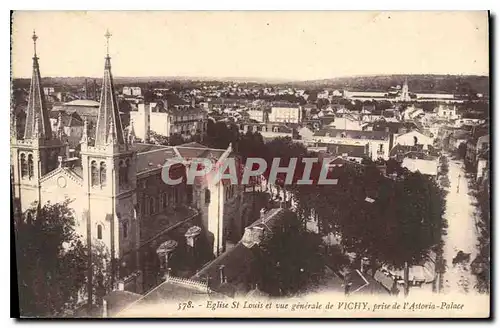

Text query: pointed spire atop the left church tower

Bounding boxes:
[24,31,52,140]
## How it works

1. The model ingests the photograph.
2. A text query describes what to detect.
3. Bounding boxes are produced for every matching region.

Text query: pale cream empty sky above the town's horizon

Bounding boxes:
[12,11,489,80]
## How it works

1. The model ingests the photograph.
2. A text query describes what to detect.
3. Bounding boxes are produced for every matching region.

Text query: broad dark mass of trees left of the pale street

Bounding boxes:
[294,163,446,272]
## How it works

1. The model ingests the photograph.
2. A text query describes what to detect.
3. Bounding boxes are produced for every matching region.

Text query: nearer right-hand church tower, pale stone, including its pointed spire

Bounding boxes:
[81,32,140,284]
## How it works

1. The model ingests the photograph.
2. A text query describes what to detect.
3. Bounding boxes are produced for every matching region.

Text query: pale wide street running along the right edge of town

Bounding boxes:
[441,158,478,294]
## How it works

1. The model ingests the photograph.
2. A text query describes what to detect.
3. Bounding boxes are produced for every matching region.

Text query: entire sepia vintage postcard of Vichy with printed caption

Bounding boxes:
[10,11,491,318]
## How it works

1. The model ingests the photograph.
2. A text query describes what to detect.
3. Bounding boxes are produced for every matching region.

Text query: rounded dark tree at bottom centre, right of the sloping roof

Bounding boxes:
[256,212,325,296]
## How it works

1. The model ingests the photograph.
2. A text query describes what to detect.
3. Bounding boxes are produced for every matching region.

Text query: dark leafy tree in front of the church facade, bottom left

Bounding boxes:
[15,201,109,317]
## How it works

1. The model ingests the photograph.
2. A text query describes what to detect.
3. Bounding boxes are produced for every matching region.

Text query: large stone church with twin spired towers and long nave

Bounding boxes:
[11,33,248,300]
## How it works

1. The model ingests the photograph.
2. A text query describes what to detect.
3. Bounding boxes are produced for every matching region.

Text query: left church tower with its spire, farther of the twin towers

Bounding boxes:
[11,31,68,210]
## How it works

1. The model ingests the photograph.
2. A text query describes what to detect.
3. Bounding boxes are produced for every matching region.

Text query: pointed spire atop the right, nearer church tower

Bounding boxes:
[95,31,125,147]
